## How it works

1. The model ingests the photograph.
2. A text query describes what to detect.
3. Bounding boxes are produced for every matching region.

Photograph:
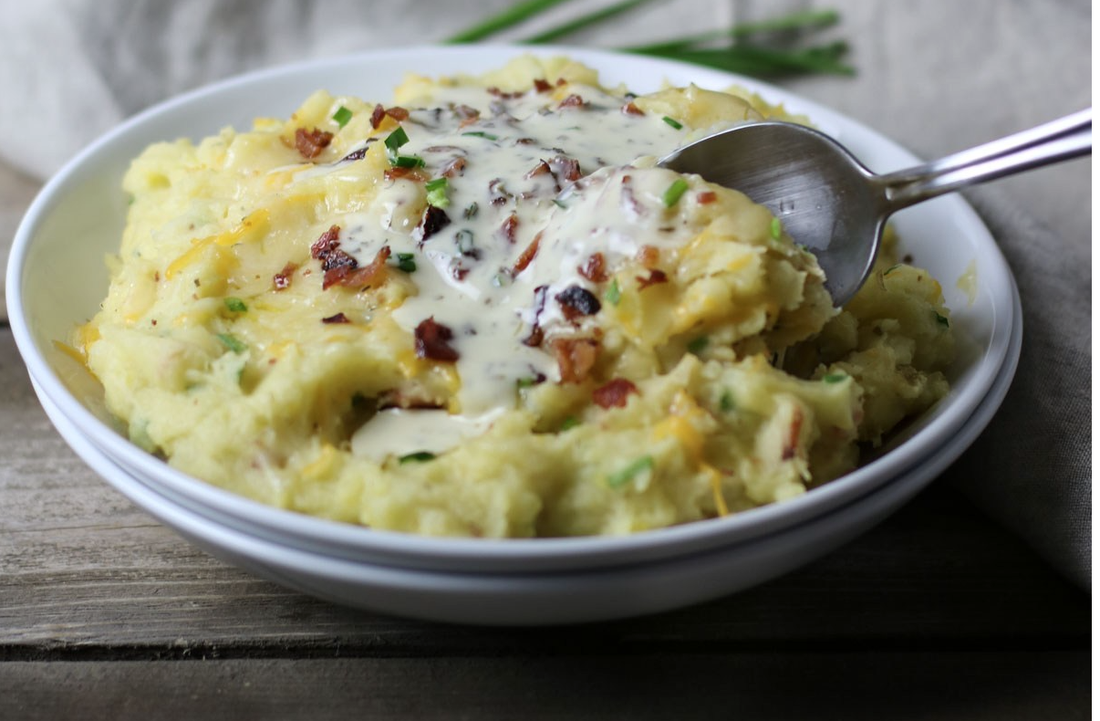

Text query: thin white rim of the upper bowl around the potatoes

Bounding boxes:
[7,45,1021,568]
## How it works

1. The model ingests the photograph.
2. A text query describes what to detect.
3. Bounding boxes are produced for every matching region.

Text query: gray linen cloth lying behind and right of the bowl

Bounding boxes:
[0,0,1091,587]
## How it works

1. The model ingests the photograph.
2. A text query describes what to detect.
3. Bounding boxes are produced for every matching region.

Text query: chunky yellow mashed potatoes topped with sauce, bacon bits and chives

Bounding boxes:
[76,57,954,536]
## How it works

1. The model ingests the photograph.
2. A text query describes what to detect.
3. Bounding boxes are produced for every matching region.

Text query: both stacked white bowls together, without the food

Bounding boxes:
[8,46,1022,625]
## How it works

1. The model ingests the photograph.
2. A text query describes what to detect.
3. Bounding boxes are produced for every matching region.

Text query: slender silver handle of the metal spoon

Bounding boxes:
[875,108,1092,212]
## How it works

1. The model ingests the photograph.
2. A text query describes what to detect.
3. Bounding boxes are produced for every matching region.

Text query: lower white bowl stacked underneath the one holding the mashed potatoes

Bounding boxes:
[35,301,1022,625]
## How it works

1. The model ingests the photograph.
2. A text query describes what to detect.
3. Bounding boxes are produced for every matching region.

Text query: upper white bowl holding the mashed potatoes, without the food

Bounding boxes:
[8,46,1020,575]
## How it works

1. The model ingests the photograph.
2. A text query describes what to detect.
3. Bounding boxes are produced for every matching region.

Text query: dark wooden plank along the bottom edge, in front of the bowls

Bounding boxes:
[0,651,1090,721]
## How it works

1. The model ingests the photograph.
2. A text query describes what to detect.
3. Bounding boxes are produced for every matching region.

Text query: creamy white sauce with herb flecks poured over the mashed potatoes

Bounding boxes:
[297,82,708,457]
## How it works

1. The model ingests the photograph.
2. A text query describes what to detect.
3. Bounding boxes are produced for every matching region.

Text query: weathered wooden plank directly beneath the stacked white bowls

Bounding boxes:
[0,330,1090,659]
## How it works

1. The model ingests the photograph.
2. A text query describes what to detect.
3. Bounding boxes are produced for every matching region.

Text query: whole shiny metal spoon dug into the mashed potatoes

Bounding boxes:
[660,108,1092,306]
